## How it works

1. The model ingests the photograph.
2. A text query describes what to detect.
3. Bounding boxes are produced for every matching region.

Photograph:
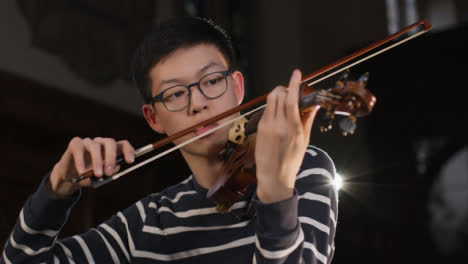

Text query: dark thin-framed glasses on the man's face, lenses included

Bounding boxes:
[151,70,232,112]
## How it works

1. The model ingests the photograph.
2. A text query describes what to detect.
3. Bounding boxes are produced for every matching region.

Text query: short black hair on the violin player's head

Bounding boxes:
[131,17,236,103]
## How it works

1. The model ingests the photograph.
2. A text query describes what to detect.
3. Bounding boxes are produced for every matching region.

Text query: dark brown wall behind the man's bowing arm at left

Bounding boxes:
[0,69,189,246]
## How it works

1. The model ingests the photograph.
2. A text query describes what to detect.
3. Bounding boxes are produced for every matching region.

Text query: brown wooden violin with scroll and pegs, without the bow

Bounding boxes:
[207,70,377,213]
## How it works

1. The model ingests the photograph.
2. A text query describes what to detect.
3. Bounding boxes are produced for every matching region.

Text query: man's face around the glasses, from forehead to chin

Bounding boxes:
[143,44,244,156]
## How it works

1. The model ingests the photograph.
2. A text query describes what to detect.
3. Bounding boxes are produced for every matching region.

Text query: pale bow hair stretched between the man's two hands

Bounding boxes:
[105,104,266,182]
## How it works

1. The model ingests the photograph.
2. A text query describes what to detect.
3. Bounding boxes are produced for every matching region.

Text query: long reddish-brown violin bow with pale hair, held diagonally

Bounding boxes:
[72,19,432,188]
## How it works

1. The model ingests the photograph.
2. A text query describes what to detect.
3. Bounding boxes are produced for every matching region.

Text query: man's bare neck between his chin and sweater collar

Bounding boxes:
[181,150,223,189]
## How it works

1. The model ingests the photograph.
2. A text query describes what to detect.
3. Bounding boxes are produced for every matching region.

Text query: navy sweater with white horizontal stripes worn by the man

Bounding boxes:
[0,146,338,263]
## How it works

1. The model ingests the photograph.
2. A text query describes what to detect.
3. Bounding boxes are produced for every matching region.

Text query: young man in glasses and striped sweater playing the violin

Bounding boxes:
[1,18,337,263]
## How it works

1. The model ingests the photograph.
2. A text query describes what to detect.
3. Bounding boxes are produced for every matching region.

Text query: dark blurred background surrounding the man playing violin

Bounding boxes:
[0,0,468,263]
